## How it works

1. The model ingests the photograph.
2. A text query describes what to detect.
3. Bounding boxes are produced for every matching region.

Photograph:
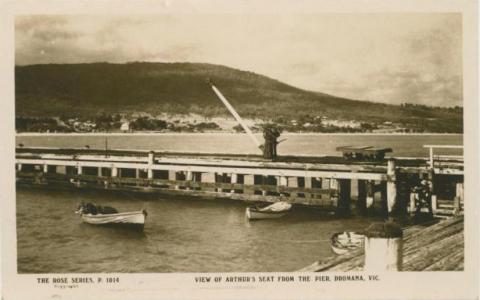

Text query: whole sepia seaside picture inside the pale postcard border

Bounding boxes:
[1,1,478,299]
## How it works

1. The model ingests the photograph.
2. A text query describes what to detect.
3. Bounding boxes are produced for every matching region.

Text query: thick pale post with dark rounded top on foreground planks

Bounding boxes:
[363,222,403,272]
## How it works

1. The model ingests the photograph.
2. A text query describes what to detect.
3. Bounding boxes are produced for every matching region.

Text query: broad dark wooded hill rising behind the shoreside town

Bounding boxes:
[15,63,463,132]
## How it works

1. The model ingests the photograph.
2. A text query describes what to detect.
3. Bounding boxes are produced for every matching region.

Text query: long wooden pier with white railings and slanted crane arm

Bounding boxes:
[15,81,464,217]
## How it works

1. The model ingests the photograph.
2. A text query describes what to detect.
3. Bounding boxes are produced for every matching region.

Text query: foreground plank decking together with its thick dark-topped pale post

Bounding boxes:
[297,216,465,272]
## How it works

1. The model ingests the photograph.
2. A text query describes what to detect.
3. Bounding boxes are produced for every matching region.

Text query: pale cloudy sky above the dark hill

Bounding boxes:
[15,13,462,106]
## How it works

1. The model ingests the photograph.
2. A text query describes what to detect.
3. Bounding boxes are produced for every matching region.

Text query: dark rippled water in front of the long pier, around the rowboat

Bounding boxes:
[17,187,380,273]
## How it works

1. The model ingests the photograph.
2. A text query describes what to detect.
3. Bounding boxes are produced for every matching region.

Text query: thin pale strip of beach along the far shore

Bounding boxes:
[15,132,463,137]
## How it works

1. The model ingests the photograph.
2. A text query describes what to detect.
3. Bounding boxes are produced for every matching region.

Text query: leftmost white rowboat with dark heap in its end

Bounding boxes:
[77,207,147,230]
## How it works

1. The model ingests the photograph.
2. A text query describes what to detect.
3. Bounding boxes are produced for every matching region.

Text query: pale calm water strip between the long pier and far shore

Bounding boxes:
[16,133,463,157]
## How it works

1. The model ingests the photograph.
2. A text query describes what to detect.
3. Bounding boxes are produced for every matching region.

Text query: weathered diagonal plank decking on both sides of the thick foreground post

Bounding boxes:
[298,216,464,272]
